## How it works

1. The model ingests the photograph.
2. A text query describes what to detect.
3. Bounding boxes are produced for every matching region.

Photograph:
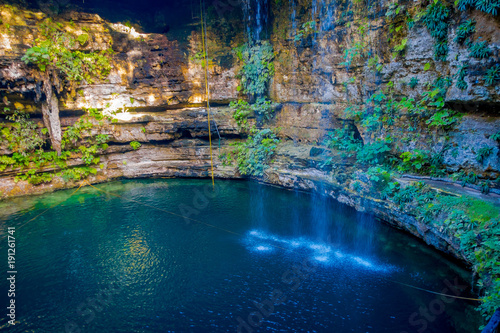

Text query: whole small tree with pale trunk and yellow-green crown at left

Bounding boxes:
[22,18,113,154]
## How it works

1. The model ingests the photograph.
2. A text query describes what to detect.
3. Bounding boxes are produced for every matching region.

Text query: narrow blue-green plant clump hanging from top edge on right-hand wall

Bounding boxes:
[423,0,450,61]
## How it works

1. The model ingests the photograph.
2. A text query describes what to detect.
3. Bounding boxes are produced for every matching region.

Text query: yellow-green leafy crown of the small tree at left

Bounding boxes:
[22,19,112,84]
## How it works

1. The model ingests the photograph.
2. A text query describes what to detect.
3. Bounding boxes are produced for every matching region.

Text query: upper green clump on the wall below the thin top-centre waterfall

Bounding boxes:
[235,41,274,96]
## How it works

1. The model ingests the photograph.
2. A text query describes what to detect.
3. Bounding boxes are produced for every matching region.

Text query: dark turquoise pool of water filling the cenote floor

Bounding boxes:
[0,179,480,332]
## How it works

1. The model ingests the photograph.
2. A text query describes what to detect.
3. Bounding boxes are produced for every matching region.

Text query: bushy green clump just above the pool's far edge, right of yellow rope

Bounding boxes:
[223,127,280,176]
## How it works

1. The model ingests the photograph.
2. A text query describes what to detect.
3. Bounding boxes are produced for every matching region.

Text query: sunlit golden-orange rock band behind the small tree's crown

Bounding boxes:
[0,6,237,111]
